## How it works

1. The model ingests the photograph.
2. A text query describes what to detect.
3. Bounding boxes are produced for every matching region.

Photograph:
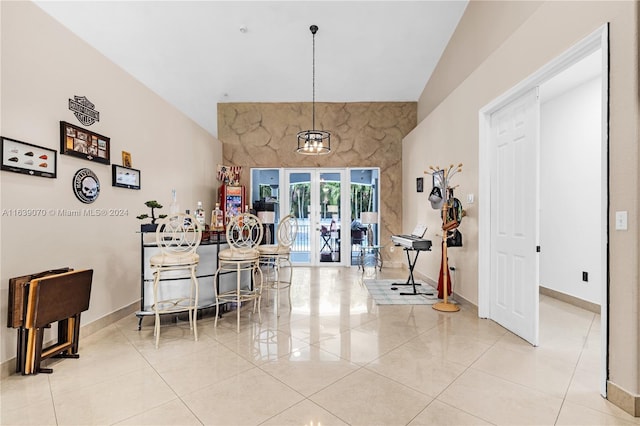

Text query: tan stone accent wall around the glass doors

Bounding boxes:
[218,102,417,261]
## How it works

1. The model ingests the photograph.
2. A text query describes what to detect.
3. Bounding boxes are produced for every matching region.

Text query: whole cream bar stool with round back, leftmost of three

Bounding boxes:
[149,213,202,348]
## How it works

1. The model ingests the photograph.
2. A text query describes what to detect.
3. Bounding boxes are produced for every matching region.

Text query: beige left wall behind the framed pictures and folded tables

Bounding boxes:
[0,1,222,362]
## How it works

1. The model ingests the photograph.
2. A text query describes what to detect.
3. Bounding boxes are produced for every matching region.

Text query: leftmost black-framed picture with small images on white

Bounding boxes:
[1,136,57,178]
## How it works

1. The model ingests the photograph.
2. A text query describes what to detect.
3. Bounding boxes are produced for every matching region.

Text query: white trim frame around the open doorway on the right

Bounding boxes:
[478,26,608,396]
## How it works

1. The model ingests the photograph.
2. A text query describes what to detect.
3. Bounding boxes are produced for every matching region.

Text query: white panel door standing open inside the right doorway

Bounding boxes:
[490,88,539,346]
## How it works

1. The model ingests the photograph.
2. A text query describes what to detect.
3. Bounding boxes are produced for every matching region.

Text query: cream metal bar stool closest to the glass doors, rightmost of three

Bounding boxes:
[258,214,298,315]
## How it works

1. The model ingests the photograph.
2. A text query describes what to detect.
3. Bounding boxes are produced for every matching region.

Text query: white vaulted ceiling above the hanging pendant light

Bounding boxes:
[36,0,467,136]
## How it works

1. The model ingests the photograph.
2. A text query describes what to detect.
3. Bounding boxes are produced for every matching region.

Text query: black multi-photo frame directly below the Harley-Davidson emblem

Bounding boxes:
[60,121,111,164]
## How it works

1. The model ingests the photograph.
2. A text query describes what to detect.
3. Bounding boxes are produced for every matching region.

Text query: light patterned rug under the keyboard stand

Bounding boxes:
[364,279,440,305]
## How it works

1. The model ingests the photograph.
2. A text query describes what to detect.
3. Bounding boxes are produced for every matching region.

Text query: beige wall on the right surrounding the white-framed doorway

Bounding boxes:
[403,1,640,406]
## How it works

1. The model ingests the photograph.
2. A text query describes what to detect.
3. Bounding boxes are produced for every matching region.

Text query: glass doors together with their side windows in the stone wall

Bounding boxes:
[250,168,379,266]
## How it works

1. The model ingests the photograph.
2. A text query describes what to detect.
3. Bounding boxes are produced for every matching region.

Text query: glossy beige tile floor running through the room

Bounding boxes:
[0,267,640,426]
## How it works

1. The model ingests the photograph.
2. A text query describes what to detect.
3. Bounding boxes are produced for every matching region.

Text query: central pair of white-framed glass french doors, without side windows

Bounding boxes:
[281,168,351,266]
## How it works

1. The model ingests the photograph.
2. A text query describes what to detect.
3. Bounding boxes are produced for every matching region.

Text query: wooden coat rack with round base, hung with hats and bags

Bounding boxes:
[425,163,462,312]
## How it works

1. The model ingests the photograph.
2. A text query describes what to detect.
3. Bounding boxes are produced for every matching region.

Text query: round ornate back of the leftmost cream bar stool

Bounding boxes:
[156,213,202,256]
